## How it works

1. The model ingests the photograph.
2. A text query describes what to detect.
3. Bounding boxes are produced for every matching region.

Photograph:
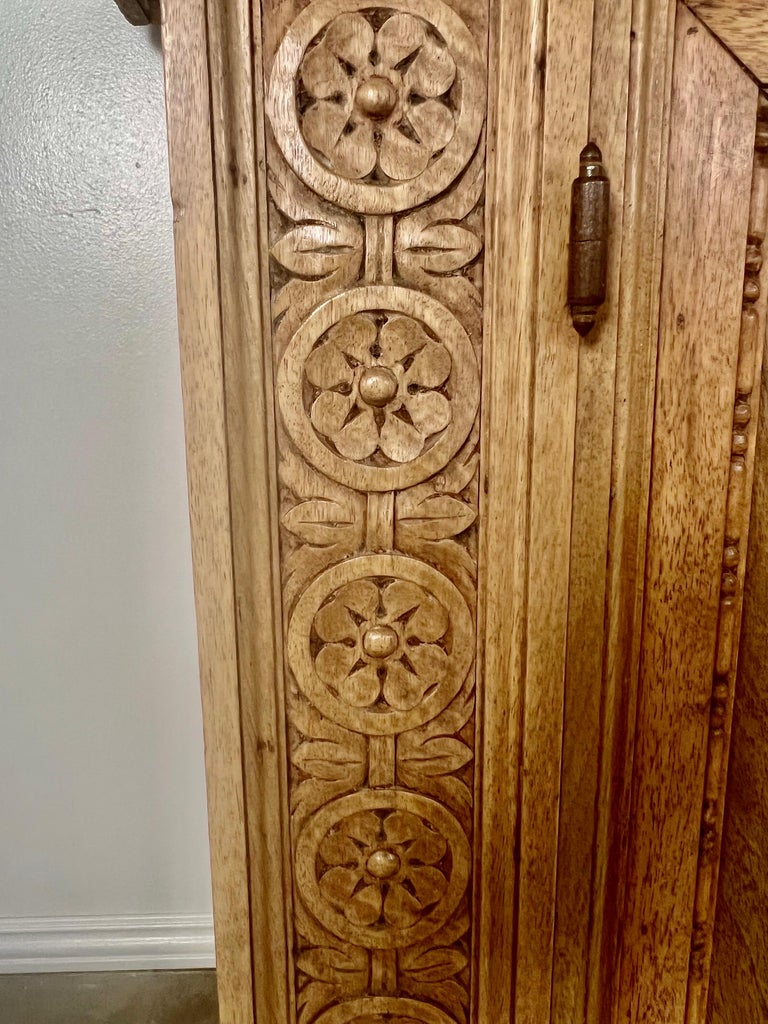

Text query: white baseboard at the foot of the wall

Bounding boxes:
[0,914,216,974]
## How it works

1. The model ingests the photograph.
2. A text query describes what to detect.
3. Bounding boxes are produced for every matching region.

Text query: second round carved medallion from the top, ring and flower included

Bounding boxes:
[278,285,480,490]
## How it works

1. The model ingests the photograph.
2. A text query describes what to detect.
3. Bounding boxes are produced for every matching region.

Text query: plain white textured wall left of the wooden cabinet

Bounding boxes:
[0,0,210,942]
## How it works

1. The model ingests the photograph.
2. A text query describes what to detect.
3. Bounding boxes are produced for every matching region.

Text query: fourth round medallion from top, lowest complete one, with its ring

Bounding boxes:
[296,790,470,950]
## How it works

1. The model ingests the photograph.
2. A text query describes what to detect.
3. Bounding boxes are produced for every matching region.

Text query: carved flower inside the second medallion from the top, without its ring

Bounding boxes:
[304,313,451,463]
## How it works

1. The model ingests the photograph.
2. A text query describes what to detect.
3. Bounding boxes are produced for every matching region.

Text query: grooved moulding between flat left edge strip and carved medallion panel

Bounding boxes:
[202,0,295,1024]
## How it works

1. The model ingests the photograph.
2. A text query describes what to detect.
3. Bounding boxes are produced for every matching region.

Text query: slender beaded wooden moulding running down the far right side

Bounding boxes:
[686,96,768,1024]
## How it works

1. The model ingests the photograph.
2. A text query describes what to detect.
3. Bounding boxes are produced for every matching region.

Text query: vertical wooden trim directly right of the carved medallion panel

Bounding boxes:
[471,0,546,1024]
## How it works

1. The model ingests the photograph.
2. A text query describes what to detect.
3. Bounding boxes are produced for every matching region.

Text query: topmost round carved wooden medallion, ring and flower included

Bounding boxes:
[267,0,485,214]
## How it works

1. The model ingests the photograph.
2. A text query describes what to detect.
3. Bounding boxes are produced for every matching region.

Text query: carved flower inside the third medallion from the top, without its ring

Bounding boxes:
[314,580,449,711]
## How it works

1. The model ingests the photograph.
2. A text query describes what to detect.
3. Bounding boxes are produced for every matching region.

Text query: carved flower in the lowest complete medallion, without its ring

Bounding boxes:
[319,811,447,928]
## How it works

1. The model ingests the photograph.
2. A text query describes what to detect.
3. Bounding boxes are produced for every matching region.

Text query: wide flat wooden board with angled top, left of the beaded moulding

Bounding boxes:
[618,8,757,1024]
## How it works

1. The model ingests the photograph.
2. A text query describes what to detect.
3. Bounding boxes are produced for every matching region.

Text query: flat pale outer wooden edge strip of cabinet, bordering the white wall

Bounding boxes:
[163,0,254,1024]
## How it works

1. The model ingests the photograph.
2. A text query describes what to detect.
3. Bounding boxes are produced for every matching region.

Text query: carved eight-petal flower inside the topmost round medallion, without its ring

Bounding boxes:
[300,13,456,181]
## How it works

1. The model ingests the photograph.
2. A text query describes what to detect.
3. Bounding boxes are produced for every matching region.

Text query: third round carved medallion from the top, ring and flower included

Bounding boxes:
[288,555,474,736]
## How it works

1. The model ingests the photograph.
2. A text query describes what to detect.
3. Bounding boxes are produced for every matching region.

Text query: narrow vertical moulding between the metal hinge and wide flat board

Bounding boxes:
[587,0,676,1024]
